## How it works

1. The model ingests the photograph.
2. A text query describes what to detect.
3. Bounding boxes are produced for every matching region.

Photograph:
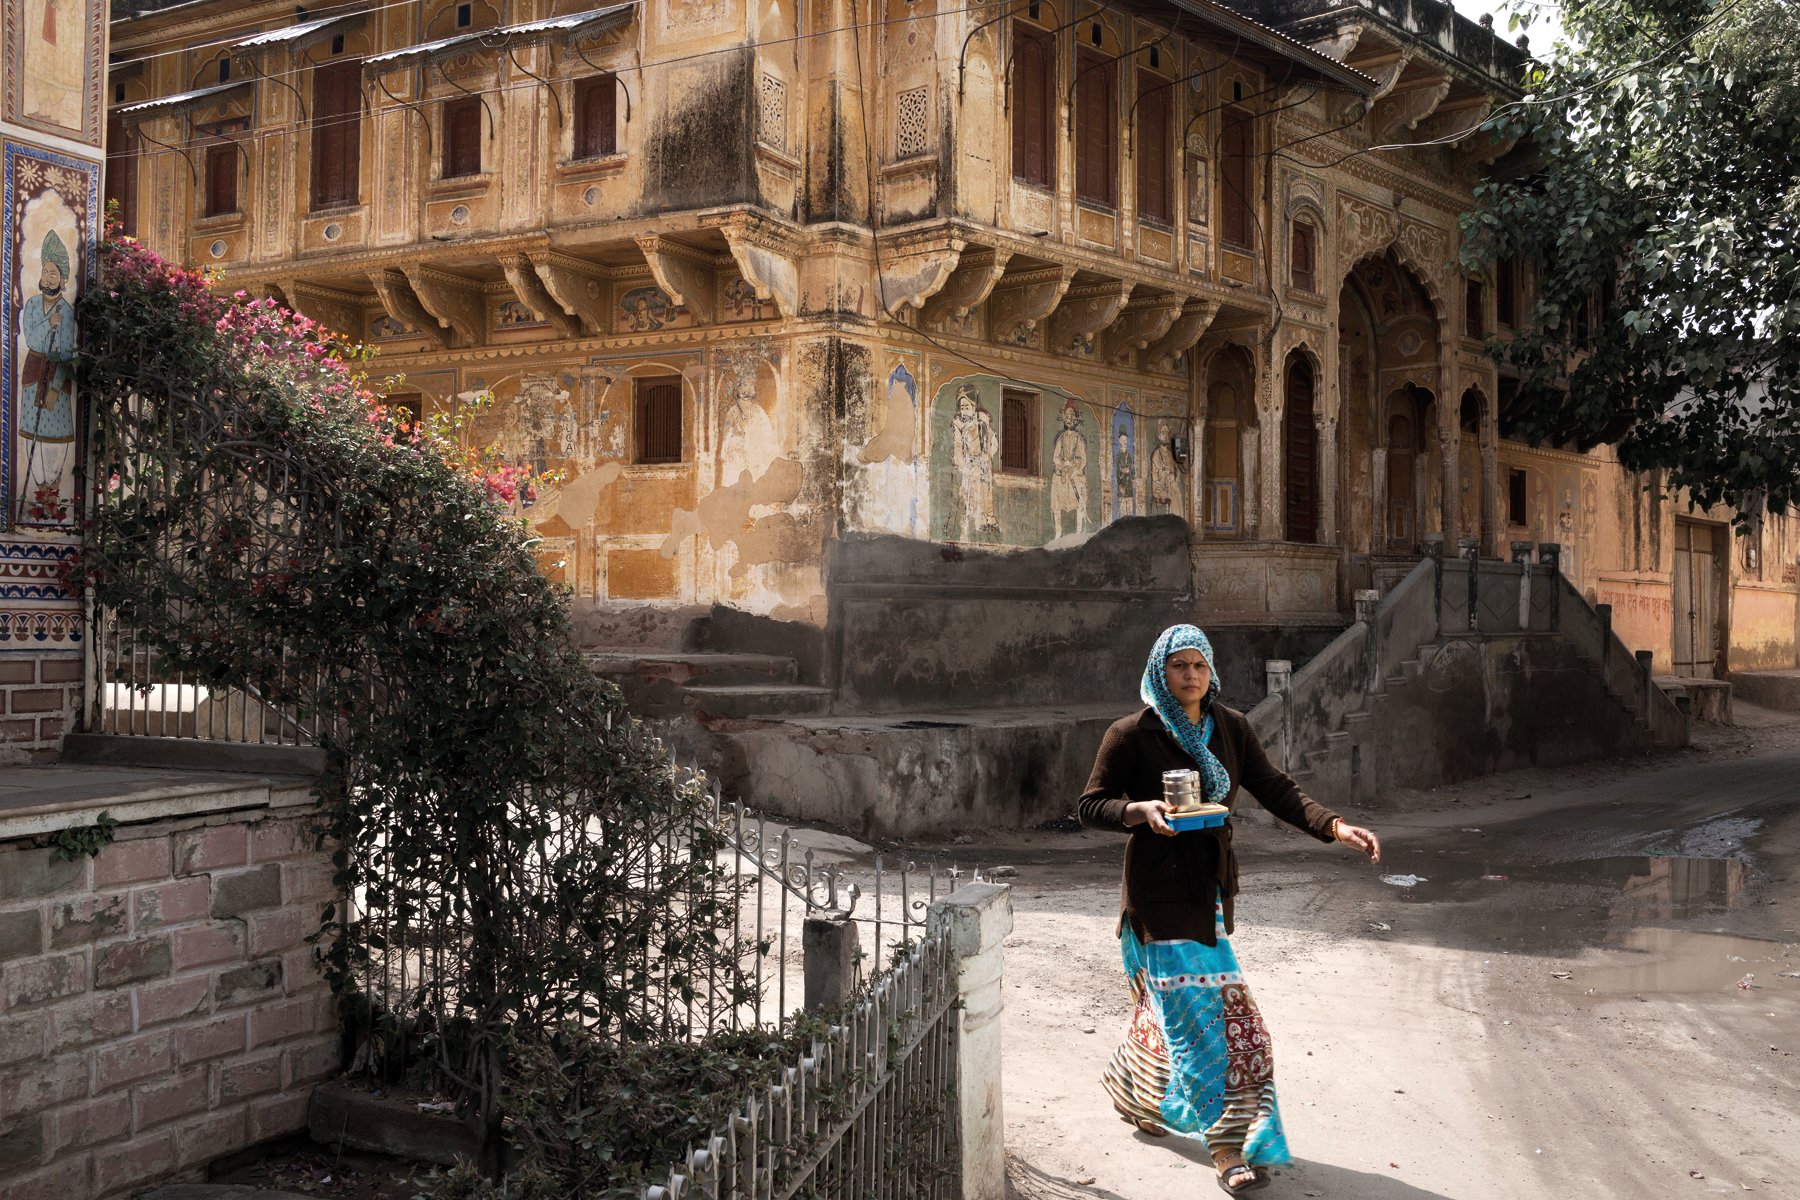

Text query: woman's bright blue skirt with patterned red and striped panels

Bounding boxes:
[1105,914,1291,1166]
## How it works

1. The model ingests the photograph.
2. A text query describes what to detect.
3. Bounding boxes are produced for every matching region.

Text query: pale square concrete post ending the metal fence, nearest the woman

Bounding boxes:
[931,883,1012,1200]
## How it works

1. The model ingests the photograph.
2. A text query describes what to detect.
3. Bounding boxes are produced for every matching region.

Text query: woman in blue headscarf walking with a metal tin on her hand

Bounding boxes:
[1080,624,1381,1195]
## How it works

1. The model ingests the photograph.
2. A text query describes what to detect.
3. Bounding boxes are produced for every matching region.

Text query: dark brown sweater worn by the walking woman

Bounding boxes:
[1078,703,1337,946]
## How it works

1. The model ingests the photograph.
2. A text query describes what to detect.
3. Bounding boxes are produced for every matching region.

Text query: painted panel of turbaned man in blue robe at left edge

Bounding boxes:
[0,142,99,531]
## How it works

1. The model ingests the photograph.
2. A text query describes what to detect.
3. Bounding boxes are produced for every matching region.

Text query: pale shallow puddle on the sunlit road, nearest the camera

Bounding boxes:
[1561,928,1800,999]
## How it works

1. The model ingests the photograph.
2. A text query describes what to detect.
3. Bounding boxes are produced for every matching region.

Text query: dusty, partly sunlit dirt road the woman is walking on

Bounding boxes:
[963,711,1800,1200]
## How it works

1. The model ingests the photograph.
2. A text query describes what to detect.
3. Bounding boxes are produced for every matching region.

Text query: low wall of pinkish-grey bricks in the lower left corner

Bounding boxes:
[0,810,340,1200]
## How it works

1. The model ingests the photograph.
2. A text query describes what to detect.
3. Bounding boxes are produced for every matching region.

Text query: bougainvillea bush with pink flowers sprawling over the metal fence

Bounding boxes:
[76,237,742,1165]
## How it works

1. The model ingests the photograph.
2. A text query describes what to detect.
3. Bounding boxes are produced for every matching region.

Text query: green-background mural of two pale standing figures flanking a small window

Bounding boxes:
[927,374,1105,545]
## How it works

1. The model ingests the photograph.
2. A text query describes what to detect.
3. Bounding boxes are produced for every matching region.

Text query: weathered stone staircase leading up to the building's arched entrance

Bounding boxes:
[1249,560,1688,804]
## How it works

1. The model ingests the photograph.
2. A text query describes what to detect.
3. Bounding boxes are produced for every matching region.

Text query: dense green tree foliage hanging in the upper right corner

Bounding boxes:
[1463,0,1800,511]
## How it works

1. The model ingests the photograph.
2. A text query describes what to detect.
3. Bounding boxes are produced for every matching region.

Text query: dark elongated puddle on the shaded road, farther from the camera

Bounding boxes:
[1384,855,1750,921]
